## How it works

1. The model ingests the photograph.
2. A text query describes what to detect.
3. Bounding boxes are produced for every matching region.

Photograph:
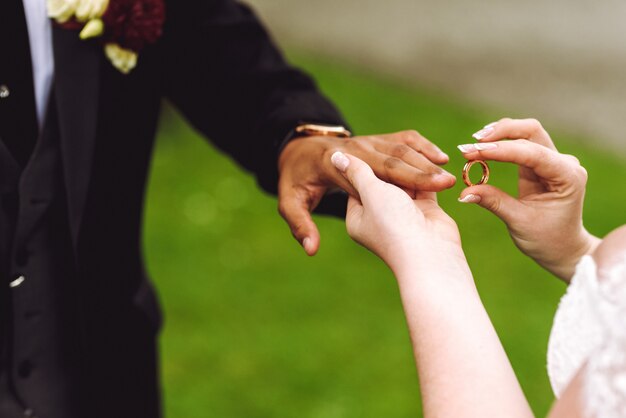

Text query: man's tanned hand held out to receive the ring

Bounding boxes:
[278,131,456,255]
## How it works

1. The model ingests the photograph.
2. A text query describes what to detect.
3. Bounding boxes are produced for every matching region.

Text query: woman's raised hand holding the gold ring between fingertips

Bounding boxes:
[459,119,599,281]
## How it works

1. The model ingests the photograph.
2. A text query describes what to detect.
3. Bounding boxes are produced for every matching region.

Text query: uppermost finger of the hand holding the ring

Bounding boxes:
[472,118,556,150]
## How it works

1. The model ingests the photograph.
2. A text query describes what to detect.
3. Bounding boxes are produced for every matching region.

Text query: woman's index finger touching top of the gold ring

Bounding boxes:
[458,140,580,182]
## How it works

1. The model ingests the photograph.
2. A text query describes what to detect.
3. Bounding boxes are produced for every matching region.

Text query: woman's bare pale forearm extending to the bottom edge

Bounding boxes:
[395,248,532,418]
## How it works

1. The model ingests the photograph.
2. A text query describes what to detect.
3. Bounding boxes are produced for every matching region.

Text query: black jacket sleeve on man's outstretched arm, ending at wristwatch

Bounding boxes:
[162,0,345,193]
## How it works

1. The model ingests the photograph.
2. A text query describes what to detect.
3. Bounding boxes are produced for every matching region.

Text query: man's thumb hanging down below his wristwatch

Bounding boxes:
[278,182,320,256]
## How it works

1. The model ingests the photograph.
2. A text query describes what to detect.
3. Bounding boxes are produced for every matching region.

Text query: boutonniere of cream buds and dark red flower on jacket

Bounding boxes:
[47,0,165,74]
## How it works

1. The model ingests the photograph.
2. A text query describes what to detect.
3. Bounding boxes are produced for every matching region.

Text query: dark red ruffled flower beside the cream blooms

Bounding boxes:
[102,0,165,52]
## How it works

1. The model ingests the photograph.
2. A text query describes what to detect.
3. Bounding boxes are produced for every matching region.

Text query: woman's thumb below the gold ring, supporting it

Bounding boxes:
[459,184,523,225]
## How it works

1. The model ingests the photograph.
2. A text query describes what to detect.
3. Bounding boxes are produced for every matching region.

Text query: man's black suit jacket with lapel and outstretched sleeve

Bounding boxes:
[40,0,344,418]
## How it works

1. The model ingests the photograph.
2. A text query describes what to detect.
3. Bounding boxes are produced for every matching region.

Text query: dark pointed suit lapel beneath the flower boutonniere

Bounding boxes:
[52,27,103,245]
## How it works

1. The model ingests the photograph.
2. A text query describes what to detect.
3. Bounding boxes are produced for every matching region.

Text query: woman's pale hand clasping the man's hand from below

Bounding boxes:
[331,152,463,275]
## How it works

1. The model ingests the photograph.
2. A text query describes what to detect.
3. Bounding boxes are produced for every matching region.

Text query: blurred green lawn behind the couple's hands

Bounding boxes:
[145,50,626,418]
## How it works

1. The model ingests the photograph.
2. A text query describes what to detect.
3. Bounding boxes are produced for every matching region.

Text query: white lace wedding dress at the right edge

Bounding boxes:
[548,255,626,418]
